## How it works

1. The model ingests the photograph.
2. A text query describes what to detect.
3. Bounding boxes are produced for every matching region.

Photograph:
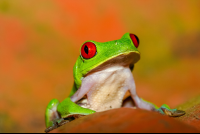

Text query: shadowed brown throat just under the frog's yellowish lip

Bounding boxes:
[83,51,140,77]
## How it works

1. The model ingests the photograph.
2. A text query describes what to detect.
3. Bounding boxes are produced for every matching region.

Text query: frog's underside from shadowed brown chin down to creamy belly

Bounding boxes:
[71,52,140,112]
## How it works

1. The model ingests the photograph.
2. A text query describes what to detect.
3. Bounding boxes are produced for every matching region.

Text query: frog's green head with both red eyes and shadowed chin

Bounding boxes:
[73,33,140,88]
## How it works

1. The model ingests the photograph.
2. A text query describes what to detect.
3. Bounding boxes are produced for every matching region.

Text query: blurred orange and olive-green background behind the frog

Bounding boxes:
[0,0,200,132]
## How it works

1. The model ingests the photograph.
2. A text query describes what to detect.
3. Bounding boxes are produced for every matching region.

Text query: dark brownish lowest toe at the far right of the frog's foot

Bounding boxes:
[161,108,185,117]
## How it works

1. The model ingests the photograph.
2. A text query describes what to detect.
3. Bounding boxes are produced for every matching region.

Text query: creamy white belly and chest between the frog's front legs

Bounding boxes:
[78,66,132,112]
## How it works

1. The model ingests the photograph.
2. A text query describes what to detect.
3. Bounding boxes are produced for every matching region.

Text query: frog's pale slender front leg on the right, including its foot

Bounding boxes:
[127,71,185,116]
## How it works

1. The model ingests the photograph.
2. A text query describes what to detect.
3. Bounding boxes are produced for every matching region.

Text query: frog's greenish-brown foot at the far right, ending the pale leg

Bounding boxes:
[156,104,185,117]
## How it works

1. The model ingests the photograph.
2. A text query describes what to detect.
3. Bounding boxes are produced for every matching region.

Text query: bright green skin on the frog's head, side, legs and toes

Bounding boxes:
[45,33,176,128]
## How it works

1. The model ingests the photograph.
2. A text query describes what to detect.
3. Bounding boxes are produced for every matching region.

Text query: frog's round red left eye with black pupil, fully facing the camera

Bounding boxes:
[81,42,97,59]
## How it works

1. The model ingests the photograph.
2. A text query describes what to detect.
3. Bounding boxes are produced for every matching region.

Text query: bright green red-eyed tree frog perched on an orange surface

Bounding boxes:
[45,33,185,132]
